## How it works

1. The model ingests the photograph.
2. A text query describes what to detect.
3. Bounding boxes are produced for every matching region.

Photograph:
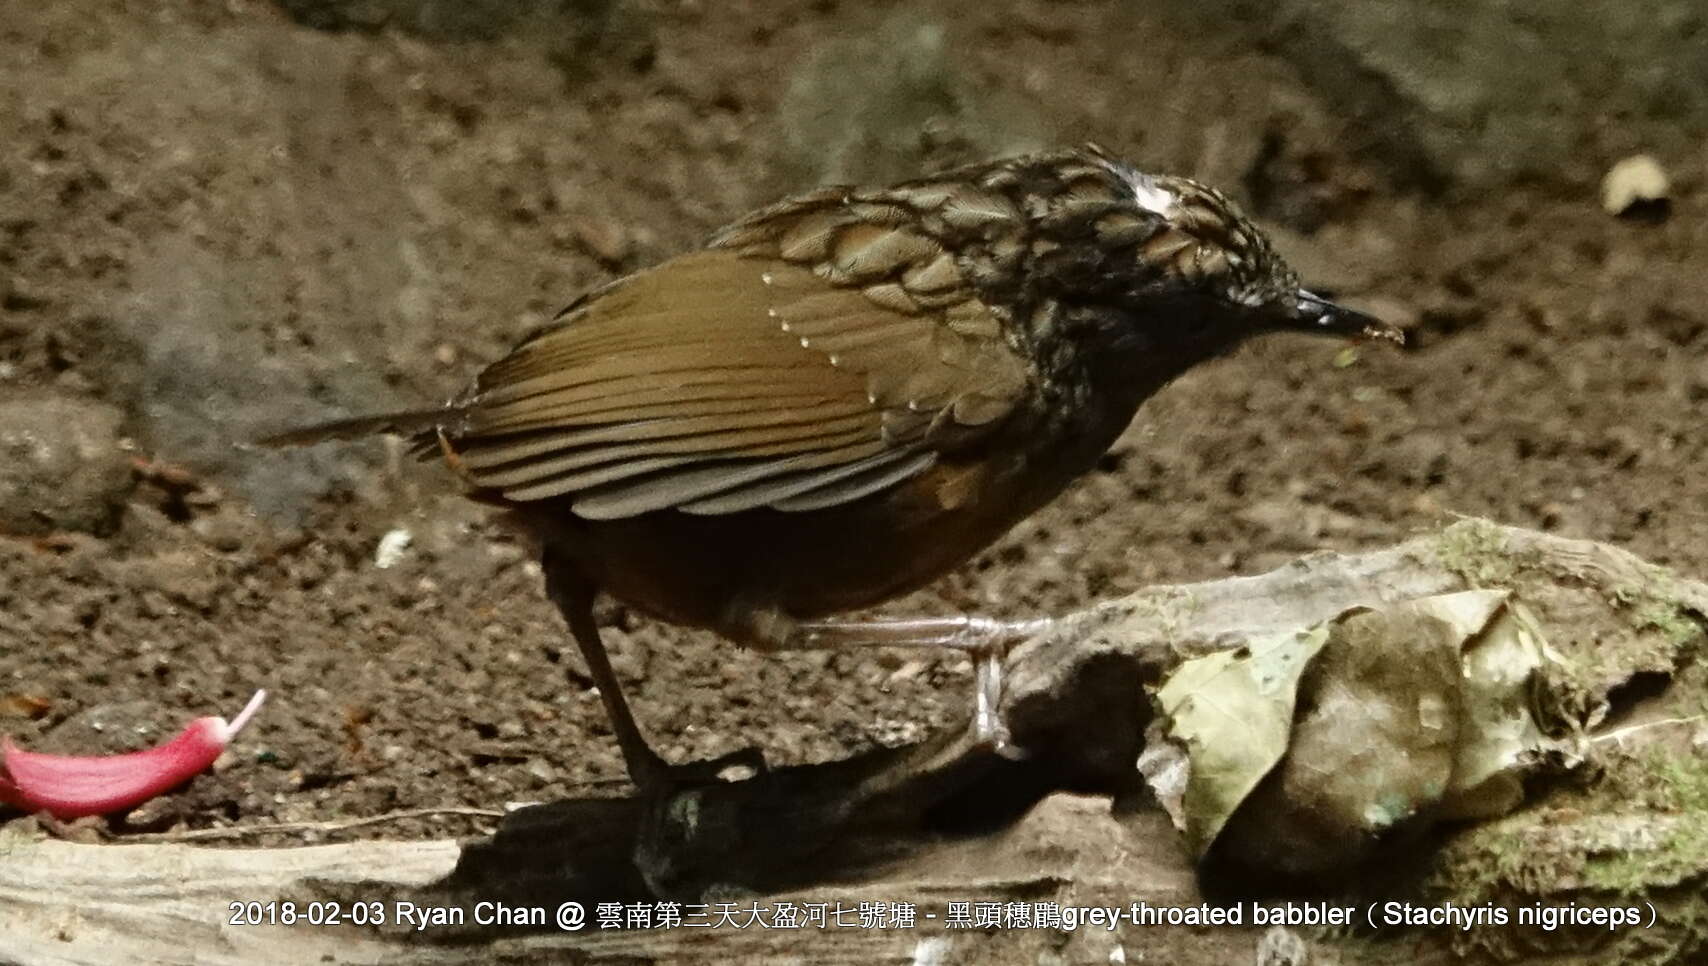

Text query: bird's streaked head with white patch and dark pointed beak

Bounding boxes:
[1112,162,1404,343]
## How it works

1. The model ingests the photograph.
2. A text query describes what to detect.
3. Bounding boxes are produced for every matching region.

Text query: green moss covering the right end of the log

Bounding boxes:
[1430,519,1708,966]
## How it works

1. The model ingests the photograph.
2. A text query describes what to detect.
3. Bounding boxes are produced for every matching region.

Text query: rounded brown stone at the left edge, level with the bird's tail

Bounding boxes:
[0,396,137,536]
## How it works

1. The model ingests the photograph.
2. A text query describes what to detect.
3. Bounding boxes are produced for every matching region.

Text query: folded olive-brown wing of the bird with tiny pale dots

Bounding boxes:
[447,210,1032,519]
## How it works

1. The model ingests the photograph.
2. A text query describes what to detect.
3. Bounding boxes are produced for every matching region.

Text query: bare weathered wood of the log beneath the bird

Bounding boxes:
[0,521,1708,966]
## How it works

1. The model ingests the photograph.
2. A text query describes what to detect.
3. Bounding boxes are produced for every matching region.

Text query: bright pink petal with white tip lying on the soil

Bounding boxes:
[0,691,266,819]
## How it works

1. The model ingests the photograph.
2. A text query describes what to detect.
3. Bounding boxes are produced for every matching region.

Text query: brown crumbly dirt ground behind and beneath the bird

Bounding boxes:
[0,0,1708,914]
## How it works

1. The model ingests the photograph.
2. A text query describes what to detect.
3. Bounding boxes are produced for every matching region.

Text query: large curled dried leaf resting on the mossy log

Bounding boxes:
[1139,591,1559,874]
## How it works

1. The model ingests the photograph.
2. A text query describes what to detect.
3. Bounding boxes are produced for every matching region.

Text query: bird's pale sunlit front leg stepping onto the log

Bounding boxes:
[750,613,1052,758]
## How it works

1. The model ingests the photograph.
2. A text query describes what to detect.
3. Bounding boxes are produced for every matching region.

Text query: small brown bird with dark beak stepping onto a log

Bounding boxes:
[266,147,1401,785]
